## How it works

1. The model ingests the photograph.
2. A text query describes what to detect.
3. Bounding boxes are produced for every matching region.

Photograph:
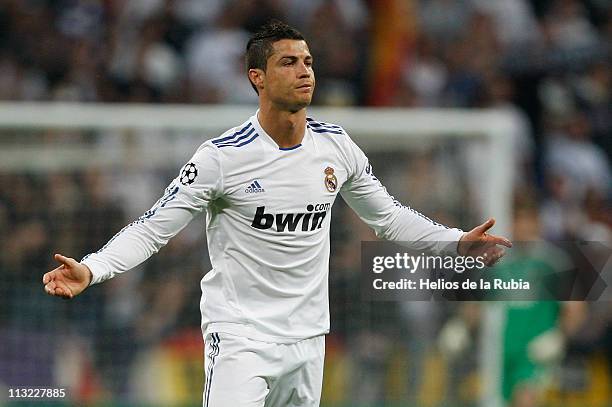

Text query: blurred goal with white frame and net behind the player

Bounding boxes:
[0,103,523,407]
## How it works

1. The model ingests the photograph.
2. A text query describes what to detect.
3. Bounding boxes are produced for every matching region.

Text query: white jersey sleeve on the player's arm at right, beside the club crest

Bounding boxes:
[341,136,463,254]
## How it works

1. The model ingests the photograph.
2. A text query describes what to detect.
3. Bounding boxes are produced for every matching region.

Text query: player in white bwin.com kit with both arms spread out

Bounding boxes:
[43,22,511,407]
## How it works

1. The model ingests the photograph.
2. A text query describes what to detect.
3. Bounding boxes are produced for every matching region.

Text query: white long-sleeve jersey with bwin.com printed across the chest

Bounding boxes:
[82,114,463,343]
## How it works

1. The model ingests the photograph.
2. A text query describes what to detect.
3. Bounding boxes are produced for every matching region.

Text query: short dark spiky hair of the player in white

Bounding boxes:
[244,20,305,94]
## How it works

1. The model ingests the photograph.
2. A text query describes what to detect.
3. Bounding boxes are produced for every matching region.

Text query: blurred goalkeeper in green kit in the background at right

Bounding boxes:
[496,199,586,407]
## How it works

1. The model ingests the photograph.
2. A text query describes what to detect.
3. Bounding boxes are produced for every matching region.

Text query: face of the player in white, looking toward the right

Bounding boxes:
[260,40,315,112]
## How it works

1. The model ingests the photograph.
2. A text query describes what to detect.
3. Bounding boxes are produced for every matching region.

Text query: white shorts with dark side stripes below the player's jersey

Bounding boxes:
[202,333,325,407]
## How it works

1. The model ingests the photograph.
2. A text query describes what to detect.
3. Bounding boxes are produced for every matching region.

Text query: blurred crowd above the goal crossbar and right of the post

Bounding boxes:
[0,0,612,230]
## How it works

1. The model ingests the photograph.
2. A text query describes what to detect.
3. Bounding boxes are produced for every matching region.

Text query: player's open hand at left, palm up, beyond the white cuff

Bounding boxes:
[43,254,92,298]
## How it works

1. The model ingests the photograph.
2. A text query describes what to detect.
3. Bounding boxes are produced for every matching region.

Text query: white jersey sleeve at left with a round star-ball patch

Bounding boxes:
[81,143,223,284]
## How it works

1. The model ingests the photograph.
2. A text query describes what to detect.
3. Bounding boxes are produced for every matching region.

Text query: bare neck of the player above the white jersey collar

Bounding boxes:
[257,105,306,148]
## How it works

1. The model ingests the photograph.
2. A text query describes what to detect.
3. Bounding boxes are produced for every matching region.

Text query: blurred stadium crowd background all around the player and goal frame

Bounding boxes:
[0,0,612,407]
